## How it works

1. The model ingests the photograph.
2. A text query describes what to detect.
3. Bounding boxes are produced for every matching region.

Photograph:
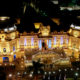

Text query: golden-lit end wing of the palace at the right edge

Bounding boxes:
[68,24,80,51]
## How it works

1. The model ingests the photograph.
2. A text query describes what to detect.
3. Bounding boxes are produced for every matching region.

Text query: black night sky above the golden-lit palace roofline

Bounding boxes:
[0,0,80,32]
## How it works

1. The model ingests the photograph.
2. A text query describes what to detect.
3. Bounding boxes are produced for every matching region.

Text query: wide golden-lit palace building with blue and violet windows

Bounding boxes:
[0,24,80,63]
